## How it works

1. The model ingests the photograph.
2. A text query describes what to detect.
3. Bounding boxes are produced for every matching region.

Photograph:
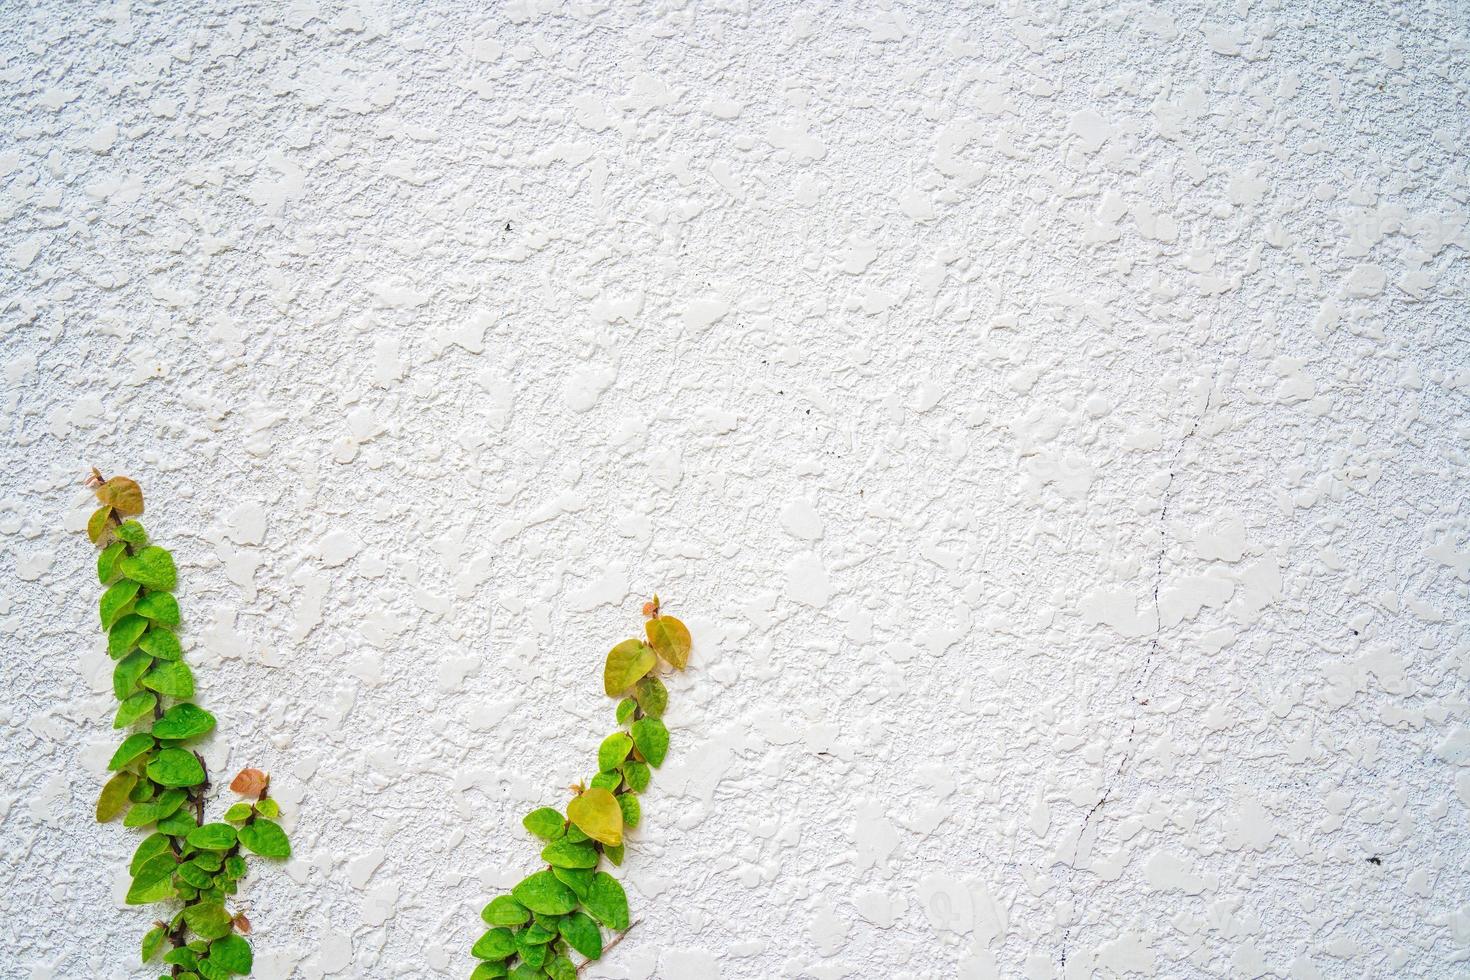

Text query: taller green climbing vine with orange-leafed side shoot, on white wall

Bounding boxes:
[87,470,291,980]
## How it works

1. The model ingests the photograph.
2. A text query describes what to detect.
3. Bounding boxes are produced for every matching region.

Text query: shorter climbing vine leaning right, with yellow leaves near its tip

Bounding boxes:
[470,595,691,980]
